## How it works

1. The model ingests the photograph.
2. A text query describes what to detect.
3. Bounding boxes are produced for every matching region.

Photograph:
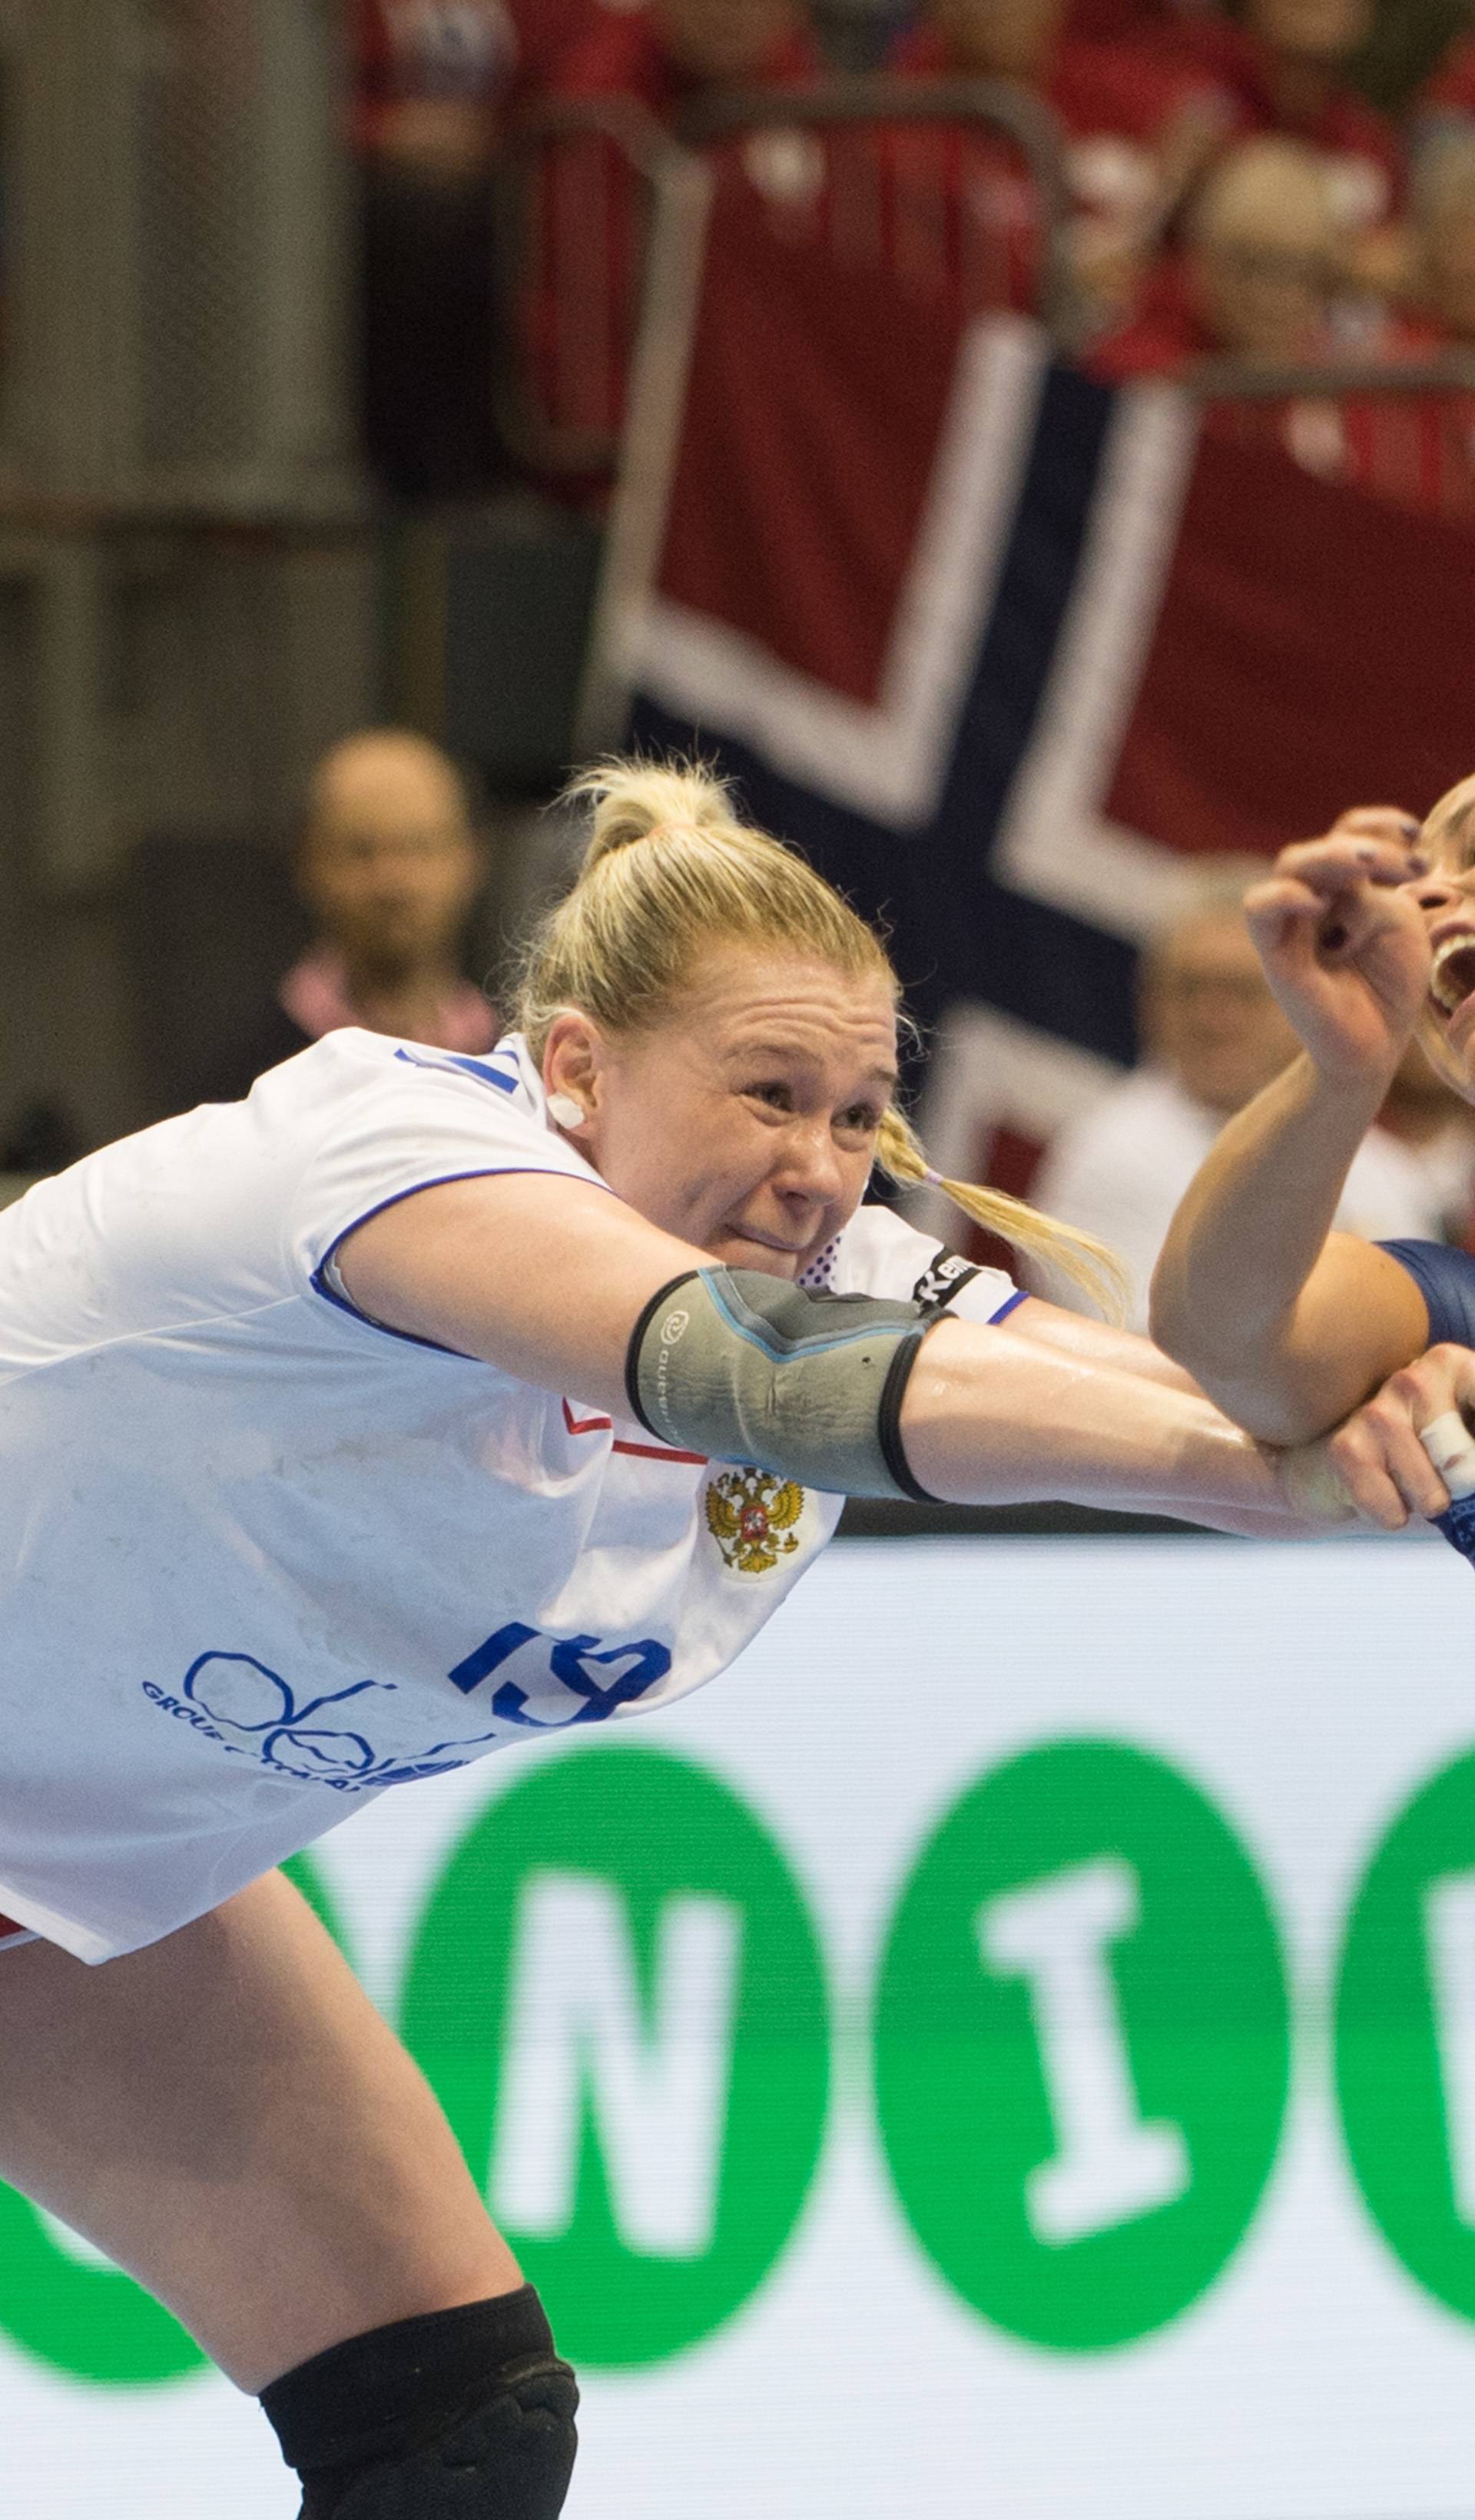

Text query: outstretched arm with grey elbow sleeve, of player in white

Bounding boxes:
[338,1174,1339,1532]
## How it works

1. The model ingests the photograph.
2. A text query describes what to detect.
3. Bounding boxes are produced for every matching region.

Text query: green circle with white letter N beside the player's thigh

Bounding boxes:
[401,1746,830,2369]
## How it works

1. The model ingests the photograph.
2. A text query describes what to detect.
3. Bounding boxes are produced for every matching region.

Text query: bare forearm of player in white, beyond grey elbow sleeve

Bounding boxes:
[903,1325,1319,1535]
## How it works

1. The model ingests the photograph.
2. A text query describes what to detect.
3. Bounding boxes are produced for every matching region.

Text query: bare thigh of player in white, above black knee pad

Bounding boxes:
[0,1872,522,2389]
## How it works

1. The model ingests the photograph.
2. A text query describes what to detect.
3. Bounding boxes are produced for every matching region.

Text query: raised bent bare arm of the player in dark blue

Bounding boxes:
[1152,814,1430,1444]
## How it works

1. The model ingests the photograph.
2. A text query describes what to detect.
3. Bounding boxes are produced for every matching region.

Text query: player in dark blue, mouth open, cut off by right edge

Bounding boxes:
[1152,779,1475,1530]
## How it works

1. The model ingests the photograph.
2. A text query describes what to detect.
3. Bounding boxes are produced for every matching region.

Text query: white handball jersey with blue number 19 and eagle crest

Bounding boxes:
[0,1031,1021,1961]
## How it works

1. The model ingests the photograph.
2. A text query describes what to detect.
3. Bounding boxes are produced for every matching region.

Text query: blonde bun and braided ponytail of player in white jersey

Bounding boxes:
[517,758,1127,1321]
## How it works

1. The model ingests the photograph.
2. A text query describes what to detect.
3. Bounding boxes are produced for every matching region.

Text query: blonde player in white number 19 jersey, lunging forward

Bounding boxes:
[0,768,1341,2520]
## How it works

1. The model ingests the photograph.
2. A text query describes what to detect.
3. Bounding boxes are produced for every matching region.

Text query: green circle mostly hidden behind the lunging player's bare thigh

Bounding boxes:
[0,1855,343,2389]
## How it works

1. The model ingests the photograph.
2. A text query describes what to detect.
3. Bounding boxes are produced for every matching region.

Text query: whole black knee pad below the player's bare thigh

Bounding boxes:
[262,2283,580,2520]
